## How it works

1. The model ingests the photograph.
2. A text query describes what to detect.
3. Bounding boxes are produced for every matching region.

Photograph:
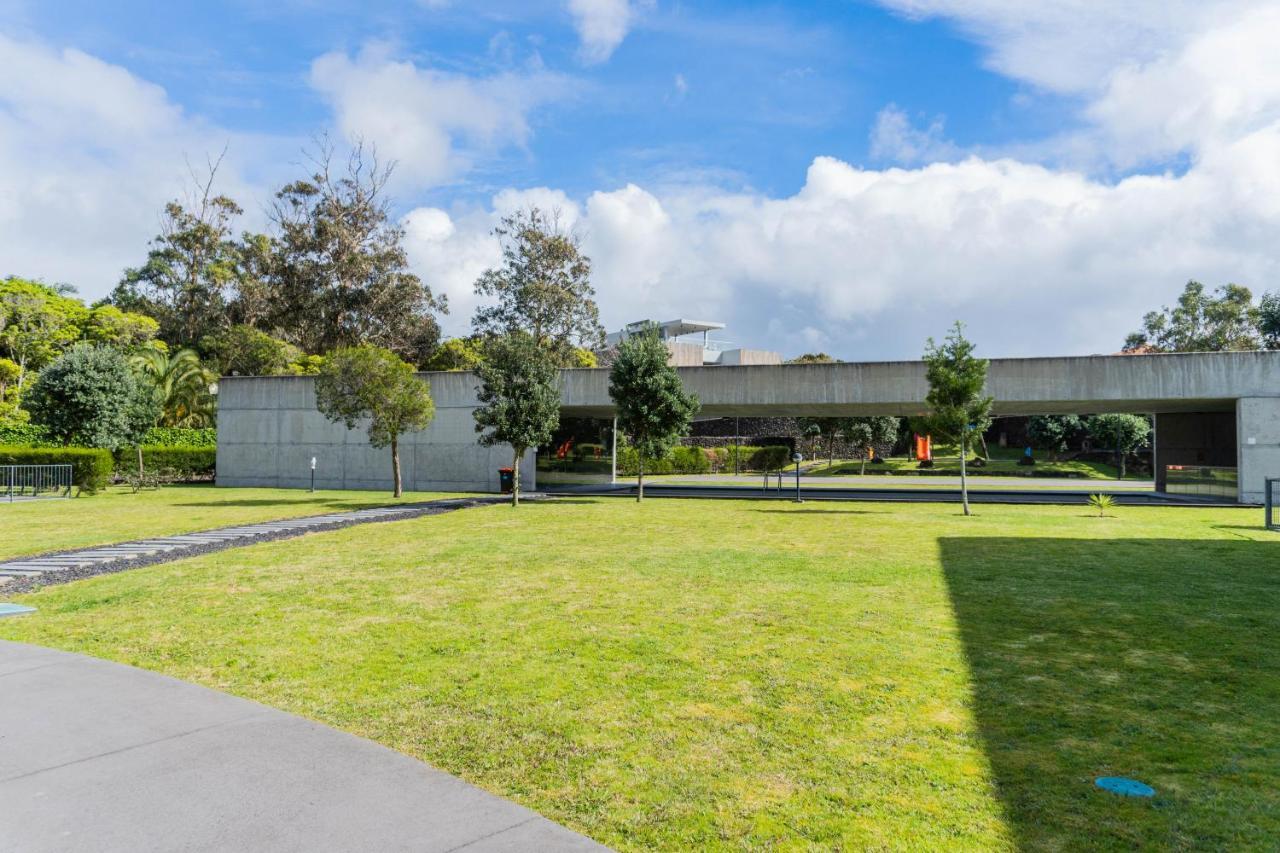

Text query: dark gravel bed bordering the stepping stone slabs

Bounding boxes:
[0,494,529,596]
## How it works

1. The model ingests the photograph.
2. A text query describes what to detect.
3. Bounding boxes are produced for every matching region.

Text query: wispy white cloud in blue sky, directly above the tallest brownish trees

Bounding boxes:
[311,44,572,188]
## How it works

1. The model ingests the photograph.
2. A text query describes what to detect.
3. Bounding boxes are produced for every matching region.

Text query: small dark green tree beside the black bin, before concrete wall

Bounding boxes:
[475,330,561,506]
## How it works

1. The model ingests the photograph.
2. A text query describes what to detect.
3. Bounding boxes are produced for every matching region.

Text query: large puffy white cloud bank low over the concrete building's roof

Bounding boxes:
[407,129,1280,359]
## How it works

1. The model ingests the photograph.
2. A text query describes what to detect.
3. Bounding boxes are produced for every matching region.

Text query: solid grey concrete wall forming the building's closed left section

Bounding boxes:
[218,373,536,492]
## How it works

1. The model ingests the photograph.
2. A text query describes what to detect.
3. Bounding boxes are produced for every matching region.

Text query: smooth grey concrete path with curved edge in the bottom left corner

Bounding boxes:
[0,642,605,853]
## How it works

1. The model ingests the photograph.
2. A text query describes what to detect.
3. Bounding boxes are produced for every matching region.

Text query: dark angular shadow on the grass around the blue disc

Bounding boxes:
[940,538,1280,849]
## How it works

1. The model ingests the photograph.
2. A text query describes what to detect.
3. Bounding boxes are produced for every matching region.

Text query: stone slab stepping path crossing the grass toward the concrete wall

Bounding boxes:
[0,496,514,593]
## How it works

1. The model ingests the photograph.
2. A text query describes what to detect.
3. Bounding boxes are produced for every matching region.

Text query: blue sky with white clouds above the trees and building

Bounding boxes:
[0,0,1280,360]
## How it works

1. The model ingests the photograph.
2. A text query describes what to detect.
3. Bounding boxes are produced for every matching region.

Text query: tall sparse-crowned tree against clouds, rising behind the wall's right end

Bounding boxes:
[471,207,604,366]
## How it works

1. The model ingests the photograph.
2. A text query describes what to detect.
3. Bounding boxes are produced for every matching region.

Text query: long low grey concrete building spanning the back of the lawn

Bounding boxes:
[218,352,1280,503]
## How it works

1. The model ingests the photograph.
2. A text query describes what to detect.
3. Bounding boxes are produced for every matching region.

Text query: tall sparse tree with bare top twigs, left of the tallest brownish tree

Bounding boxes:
[109,150,244,347]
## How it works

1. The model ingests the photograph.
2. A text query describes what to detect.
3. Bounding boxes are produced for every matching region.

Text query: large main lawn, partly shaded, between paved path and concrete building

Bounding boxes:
[0,498,1280,850]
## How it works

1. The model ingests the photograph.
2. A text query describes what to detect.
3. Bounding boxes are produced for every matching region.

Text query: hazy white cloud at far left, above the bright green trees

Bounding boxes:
[0,35,274,297]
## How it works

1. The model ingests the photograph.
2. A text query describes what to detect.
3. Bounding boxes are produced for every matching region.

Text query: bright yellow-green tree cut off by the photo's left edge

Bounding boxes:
[0,278,88,396]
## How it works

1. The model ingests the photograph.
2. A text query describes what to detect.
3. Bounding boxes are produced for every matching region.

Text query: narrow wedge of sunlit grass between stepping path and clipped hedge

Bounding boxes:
[0,485,473,560]
